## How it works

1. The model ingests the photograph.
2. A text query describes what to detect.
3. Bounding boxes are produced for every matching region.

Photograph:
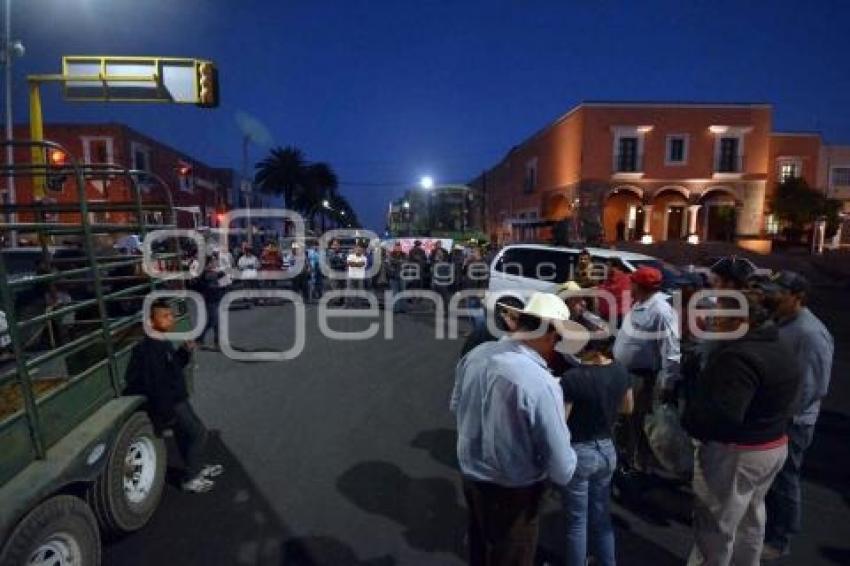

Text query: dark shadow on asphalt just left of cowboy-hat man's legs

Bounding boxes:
[337,461,466,557]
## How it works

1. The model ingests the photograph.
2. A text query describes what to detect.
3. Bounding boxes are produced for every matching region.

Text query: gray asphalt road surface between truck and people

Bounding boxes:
[104,288,850,566]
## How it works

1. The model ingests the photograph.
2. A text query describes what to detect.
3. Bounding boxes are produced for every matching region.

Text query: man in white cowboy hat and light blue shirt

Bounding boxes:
[450,293,583,566]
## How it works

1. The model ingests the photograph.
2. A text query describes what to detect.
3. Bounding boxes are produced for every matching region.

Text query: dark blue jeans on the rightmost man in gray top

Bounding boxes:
[764,424,815,551]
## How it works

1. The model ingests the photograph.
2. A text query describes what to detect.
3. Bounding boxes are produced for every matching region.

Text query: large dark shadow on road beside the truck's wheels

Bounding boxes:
[103,432,382,566]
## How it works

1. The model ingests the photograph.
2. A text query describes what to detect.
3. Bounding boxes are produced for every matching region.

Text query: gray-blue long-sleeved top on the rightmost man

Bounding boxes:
[779,307,835,425]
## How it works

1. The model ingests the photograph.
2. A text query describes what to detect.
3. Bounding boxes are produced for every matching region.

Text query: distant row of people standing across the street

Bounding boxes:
[190,239,493,349]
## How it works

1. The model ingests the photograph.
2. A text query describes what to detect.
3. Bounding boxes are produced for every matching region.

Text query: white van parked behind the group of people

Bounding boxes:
[486,244,679,307]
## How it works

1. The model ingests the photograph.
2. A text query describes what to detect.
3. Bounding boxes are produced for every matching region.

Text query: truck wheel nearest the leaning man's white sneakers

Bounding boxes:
[86,412,166,537]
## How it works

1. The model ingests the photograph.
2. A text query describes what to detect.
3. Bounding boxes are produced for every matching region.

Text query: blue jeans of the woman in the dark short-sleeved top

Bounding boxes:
[563,439,617,566]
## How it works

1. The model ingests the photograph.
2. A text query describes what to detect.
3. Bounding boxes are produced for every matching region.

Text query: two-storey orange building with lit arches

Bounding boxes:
[480,102,832,246]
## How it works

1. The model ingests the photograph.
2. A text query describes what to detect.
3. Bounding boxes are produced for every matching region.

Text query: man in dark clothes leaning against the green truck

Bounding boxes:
[124,299,223,493]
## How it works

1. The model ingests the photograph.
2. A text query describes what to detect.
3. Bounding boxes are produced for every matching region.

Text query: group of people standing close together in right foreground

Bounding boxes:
[450,257,834,565]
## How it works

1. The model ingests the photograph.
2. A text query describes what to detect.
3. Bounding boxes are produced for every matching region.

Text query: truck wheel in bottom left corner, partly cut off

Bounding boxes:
[0,495,100,566]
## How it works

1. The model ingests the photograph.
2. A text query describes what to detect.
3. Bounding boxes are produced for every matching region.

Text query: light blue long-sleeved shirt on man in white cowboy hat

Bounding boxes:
[449,338,576,487]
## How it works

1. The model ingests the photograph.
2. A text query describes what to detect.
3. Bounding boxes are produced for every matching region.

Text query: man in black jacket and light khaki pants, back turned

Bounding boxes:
[683,290,801,566]
